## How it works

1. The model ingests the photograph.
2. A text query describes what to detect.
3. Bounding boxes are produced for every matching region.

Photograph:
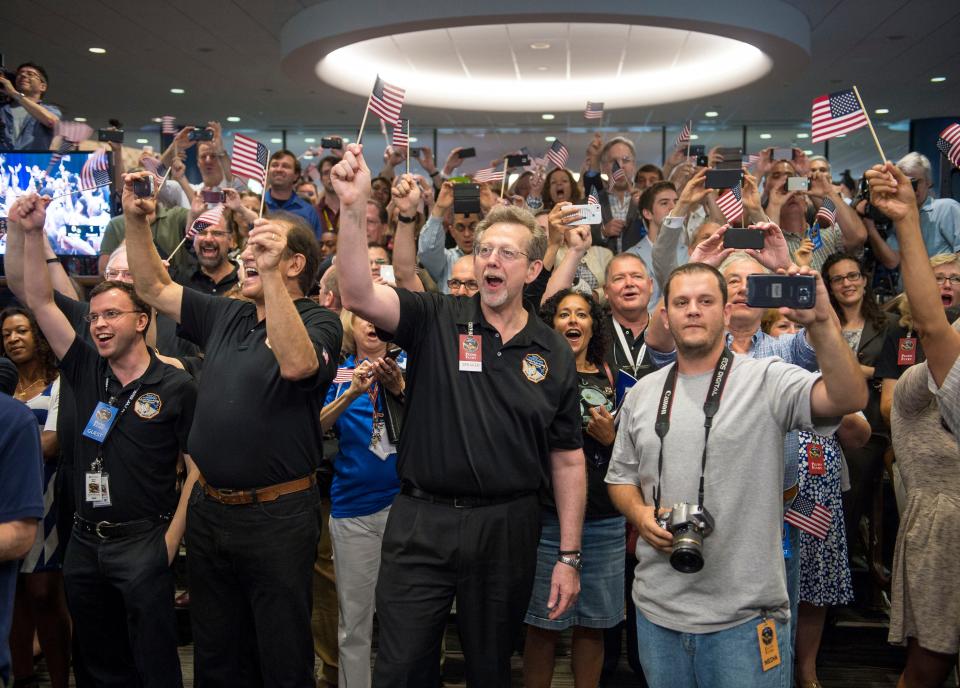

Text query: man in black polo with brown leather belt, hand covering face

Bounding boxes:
[123,169,342,687]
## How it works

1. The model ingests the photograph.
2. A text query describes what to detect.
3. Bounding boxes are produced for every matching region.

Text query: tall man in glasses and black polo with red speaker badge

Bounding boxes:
[331,144,586,688]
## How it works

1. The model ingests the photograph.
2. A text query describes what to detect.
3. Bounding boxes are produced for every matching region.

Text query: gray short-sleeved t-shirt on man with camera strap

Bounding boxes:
[606,355,840,633]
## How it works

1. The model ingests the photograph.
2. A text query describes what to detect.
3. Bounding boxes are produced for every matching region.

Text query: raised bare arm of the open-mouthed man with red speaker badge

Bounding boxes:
[330,143,402,332]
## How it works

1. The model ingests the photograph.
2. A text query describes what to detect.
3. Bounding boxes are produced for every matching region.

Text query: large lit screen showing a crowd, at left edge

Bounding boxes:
[0,150,110,256]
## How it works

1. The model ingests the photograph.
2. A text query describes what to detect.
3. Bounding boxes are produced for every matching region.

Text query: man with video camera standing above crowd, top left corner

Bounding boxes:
[0,62,60,150]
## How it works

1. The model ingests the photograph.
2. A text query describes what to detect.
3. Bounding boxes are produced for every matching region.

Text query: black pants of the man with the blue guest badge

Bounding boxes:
[63,525,183,688]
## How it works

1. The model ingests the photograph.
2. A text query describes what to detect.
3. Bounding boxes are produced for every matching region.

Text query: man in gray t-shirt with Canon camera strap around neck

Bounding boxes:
[606,263,867,688]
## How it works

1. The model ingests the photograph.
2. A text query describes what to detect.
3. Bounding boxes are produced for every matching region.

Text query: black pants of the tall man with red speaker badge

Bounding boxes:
[373,495,540,688]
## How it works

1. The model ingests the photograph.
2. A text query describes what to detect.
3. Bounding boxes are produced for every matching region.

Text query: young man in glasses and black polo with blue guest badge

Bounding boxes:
[18,198,198,686]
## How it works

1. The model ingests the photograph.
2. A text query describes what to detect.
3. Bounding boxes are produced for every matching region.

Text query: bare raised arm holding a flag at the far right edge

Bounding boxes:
[867,161,960,386]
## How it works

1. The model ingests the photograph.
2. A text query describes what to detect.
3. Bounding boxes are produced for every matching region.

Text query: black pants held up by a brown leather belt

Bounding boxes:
[187,485,320,688]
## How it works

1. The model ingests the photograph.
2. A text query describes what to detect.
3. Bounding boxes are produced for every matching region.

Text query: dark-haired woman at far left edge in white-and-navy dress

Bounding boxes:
[0,306,70,688]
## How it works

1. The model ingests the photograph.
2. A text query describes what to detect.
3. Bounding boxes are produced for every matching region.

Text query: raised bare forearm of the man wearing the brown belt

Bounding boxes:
[123,172,183,322]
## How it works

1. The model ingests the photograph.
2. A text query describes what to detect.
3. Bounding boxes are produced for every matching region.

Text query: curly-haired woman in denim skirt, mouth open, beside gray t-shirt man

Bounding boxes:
[523,289,625,688]
